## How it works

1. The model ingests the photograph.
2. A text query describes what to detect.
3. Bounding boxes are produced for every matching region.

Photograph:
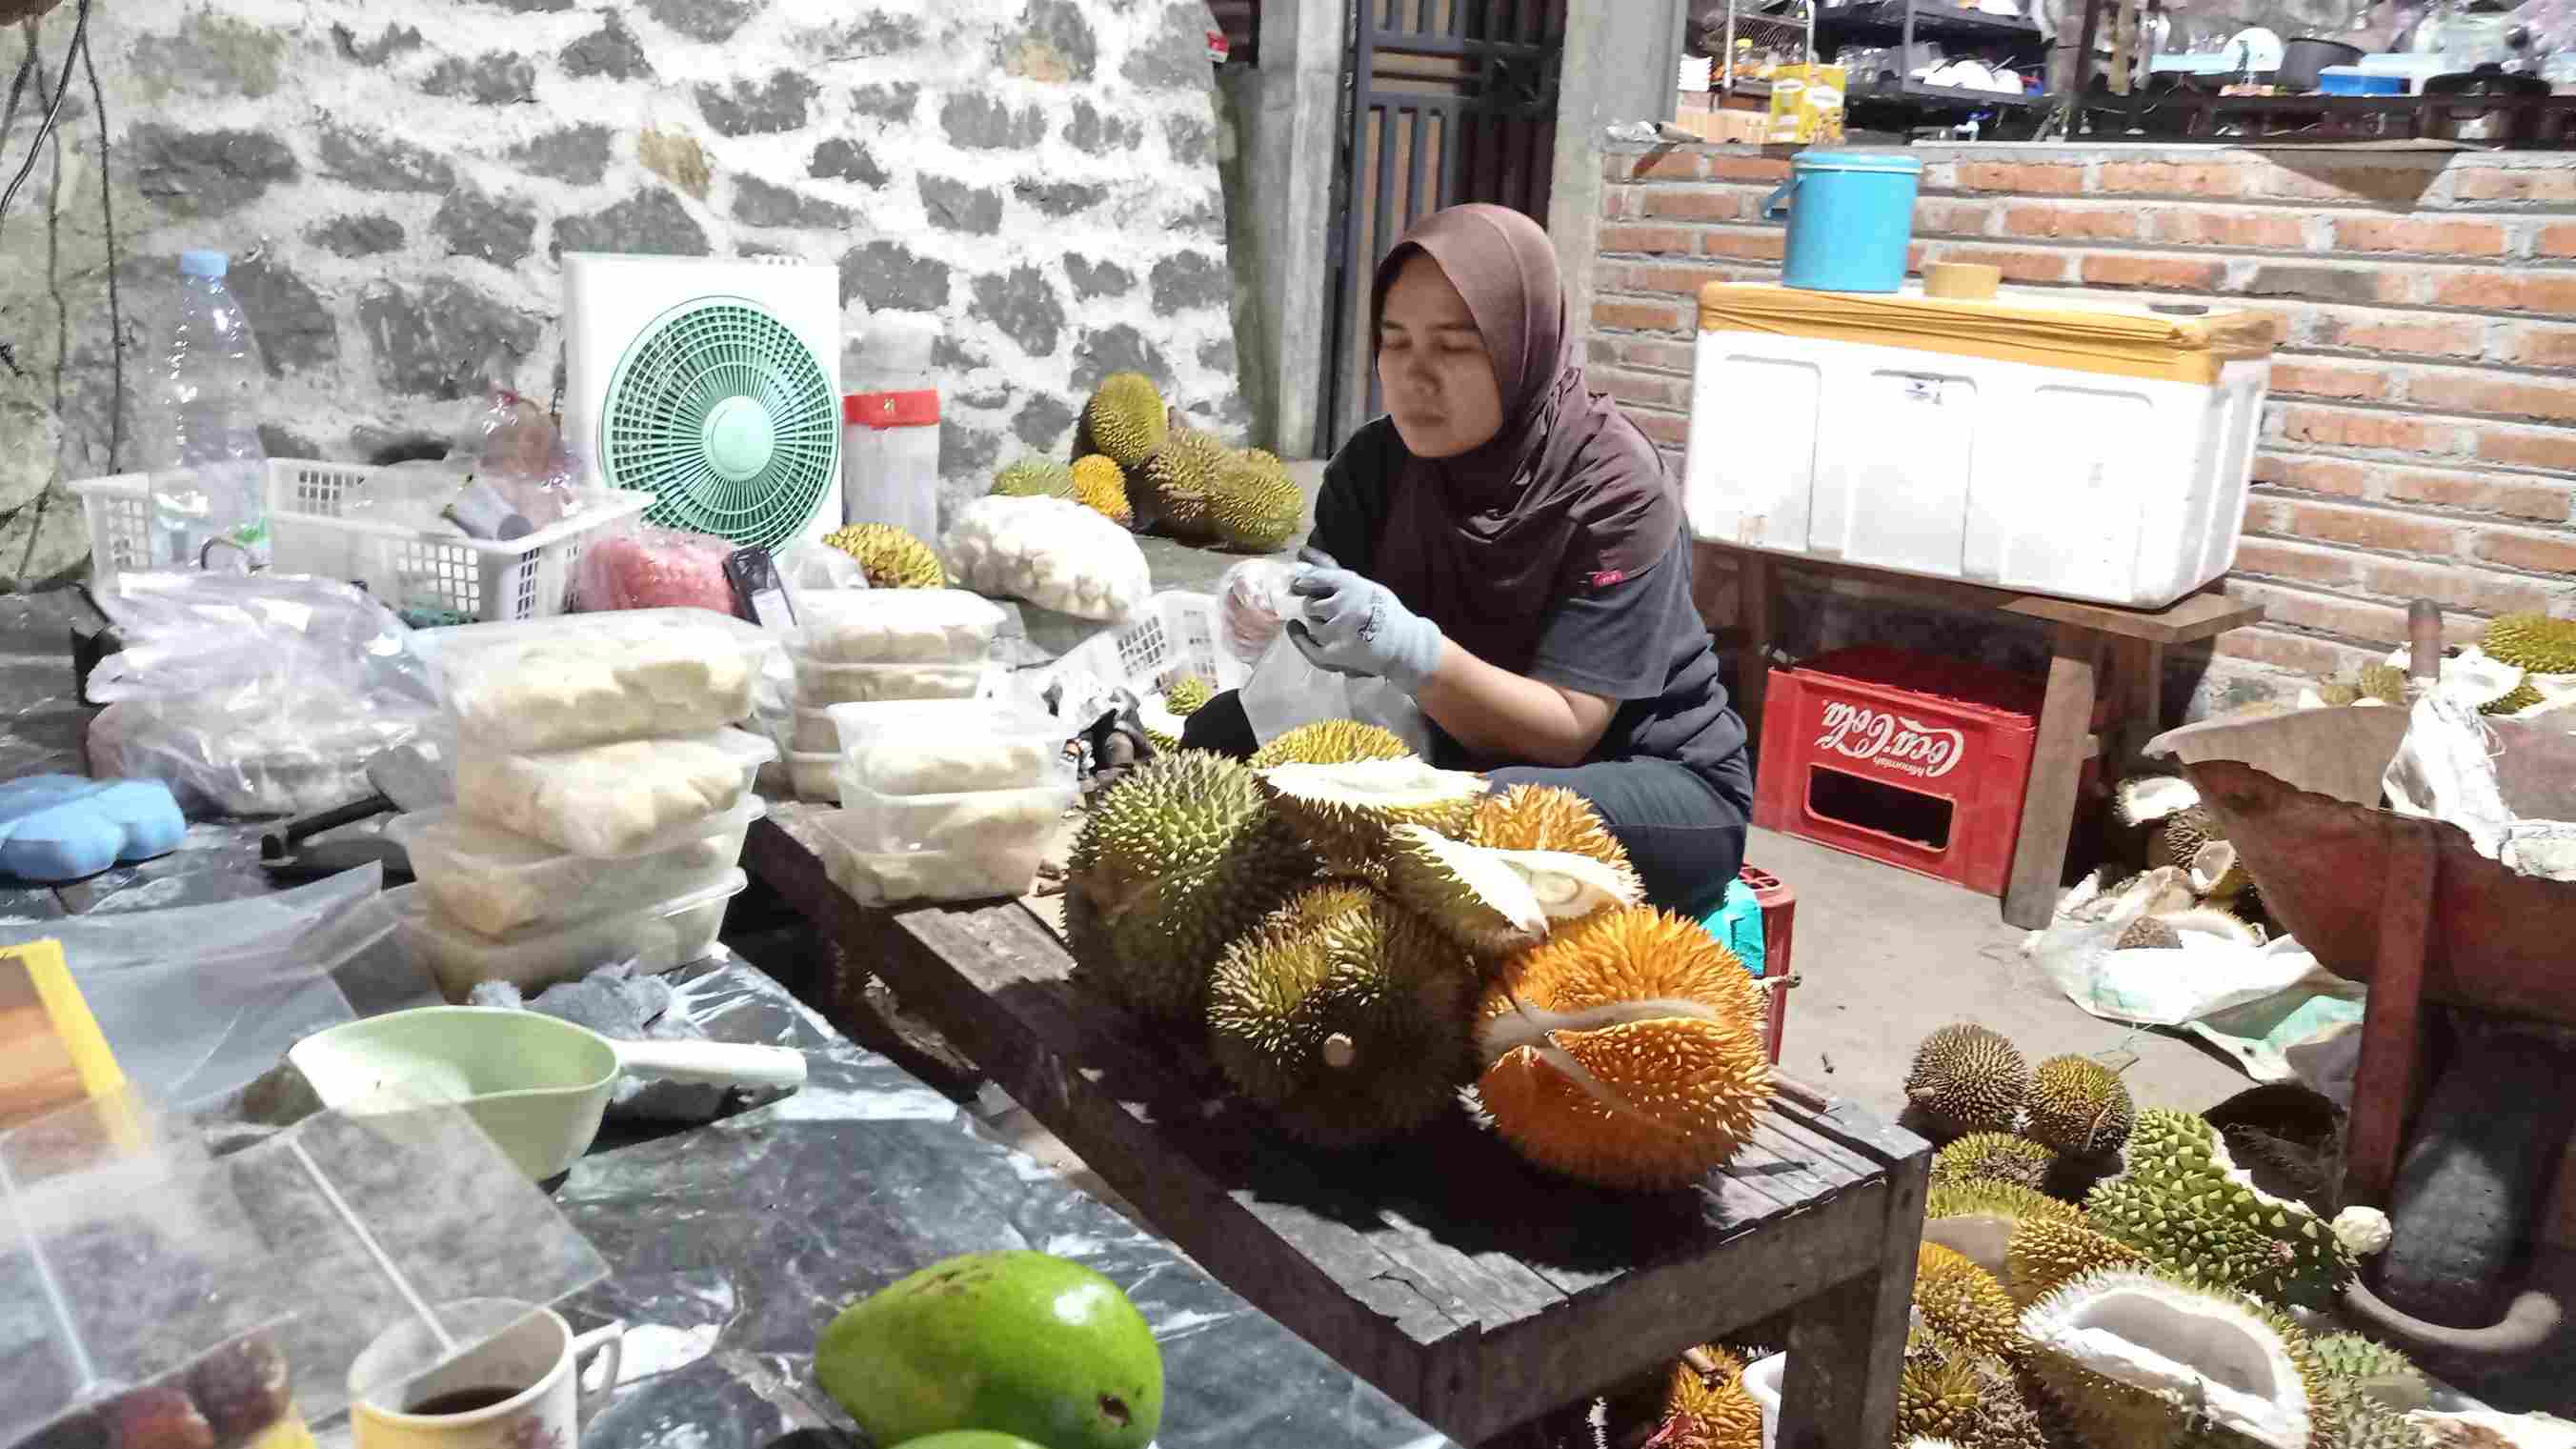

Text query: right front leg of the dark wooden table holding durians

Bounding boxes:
[1778,1153,1929,1449]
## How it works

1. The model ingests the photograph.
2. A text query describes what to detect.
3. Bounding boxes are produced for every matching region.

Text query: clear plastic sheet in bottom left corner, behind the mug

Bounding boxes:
[0,1094,608,1449]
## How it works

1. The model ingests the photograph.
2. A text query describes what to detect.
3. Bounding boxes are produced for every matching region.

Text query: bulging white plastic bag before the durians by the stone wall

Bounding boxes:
[940,497,1154,624]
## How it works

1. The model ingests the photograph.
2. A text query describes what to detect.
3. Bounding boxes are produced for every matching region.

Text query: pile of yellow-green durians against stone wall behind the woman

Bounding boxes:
[1019,372,1306,554]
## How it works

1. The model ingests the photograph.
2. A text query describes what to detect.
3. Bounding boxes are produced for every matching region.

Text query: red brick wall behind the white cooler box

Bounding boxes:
[1592,145,2576,709]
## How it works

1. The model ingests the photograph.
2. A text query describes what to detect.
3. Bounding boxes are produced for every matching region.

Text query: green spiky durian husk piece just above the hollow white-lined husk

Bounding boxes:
[2084,1109,2354,1307]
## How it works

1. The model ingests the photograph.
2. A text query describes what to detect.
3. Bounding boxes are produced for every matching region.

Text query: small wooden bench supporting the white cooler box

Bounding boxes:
[1702,539,2262,931]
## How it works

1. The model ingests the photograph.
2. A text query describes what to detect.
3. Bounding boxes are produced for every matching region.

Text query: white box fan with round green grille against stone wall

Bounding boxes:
[564,252,842,547]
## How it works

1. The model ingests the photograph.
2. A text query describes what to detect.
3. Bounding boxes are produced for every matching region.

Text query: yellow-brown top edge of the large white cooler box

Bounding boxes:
[1701,281,2272,384]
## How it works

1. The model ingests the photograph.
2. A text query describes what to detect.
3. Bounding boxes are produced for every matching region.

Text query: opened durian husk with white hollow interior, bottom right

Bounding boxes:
[2023,1269,2334,1449]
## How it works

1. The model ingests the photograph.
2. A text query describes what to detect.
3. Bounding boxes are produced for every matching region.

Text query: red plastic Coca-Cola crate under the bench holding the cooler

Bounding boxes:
[1754,647,2045,895]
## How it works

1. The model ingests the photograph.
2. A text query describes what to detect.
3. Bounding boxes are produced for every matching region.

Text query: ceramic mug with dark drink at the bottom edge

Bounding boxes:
[348,1299,626,1449]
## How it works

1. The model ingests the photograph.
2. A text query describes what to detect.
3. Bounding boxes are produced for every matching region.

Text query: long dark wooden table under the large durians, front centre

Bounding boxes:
[744,804,1929,1449]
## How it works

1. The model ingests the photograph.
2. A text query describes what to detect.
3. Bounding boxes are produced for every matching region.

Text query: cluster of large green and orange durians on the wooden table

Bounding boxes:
[1064,719,1772,1189]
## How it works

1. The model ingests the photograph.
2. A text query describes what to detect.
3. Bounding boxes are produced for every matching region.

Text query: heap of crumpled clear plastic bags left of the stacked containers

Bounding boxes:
[88,573,438,815]
